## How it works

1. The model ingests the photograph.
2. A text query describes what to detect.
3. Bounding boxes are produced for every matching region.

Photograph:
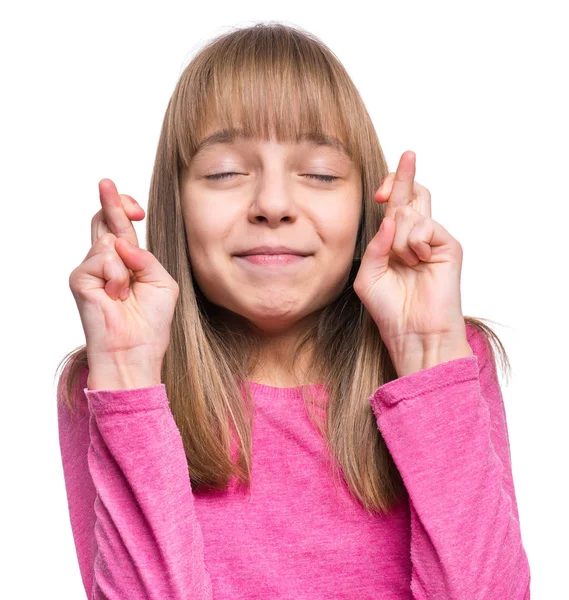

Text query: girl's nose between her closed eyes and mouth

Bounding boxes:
[249,169,297,228]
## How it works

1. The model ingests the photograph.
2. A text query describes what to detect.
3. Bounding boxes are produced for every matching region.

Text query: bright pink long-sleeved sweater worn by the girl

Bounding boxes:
[58,325,530,600]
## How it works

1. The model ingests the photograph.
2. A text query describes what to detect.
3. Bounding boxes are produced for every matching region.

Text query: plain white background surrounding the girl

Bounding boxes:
[0,0,569,600]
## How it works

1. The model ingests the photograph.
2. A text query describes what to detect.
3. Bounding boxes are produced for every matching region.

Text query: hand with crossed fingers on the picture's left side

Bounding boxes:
[69,179,179,389]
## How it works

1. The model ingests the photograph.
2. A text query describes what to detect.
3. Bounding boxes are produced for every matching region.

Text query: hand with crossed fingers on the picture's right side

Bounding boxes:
[354,151,472,377]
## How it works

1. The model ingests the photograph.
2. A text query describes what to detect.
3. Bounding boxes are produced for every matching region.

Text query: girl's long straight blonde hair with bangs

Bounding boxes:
[58,22,509,513]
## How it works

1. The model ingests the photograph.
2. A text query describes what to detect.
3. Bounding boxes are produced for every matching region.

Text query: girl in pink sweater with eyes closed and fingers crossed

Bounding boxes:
[58,23,530,600]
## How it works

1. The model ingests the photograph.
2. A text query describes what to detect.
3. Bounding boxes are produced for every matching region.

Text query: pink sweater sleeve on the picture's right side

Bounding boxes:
[370,326,530,600]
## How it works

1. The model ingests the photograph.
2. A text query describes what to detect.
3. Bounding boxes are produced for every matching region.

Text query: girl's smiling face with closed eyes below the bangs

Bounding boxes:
[181,130,362,333]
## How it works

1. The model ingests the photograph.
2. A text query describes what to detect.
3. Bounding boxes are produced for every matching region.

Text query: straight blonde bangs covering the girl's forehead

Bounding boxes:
[173,25,361,169]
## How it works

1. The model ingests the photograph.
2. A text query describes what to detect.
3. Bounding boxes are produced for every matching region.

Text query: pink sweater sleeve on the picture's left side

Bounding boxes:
[58,366,212,600]
